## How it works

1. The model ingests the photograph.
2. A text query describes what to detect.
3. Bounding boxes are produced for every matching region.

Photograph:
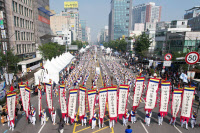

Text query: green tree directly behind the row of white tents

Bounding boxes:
[39,42,66,60]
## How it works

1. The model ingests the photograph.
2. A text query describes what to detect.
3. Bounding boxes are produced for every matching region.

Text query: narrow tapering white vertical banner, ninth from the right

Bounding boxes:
[88,90,96,124]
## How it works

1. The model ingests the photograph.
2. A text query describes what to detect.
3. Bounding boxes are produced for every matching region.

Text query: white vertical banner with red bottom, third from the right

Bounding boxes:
[160,82,171,116]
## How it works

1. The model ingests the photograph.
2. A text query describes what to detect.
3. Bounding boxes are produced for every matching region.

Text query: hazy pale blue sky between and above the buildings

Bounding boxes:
[50,0,200,41]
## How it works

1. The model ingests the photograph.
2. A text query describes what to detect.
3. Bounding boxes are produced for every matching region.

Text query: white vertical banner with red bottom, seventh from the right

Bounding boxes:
[108,87,117,121]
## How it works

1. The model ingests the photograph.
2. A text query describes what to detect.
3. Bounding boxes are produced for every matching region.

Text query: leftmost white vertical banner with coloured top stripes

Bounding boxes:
[7,92,16,123]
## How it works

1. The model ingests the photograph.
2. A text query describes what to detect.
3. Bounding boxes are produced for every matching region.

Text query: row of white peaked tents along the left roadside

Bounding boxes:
[34,52,74,85]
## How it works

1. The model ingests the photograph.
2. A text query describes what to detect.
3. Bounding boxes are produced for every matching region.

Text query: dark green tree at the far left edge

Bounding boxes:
[0,51,20,73]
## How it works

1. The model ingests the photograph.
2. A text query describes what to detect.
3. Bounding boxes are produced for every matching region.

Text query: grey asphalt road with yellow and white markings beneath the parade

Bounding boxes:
[0,48,200,133]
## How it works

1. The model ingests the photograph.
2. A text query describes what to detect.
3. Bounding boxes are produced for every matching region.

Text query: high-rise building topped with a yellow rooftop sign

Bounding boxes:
[62,1,80,40]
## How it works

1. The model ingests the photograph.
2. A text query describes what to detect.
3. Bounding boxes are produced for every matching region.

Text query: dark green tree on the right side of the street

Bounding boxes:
[135,33,152,56]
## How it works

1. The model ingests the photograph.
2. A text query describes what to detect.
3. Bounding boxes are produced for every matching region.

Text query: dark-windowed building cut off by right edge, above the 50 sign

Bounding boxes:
[184,6,200,31]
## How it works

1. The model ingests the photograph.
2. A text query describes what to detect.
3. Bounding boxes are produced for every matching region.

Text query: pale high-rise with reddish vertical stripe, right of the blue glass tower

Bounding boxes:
[132,2,162,29]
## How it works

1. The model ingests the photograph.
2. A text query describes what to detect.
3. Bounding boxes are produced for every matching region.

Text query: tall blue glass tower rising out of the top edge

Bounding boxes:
[109,0,132,40]
